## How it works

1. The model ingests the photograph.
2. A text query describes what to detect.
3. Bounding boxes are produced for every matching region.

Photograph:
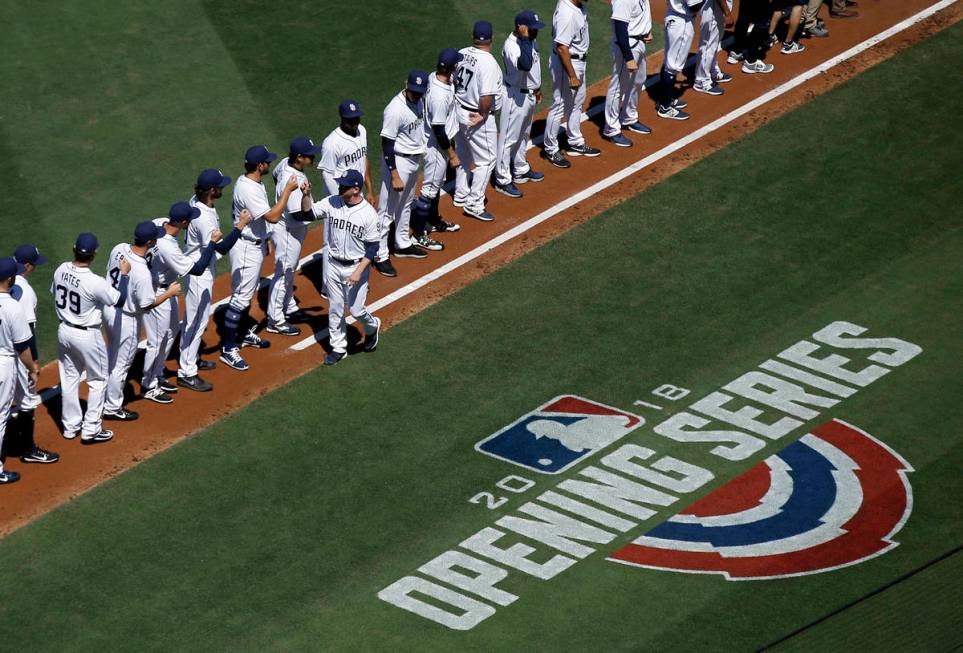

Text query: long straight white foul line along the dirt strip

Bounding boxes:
[290,0,957,351]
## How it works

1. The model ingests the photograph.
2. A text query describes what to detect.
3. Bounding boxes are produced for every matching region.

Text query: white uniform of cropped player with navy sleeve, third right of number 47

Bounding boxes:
[602,0,652,136]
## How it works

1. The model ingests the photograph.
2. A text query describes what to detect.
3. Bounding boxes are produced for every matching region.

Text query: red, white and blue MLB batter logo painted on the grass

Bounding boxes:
[475,395,645,474]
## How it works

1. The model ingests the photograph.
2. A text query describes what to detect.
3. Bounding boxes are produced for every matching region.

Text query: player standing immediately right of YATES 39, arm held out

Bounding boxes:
[104,220,181,421]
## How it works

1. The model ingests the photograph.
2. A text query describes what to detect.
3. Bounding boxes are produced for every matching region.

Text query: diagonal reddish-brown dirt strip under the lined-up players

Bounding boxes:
[0,0,963,537]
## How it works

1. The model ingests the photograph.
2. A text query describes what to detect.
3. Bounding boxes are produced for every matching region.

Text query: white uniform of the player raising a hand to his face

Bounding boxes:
[495,32,542,185]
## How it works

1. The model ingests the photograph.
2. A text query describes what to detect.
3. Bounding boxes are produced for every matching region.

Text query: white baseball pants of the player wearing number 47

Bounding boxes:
[454,106,498,212]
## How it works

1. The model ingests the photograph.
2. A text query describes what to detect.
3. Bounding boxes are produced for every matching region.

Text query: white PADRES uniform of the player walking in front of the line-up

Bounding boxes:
[314,195,381,353]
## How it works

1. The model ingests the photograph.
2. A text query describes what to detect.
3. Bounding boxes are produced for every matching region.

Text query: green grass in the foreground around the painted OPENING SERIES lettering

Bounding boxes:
[0,12,963,651]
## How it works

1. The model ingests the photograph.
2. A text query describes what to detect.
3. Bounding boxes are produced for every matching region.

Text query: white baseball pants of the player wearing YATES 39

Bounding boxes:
[57,324,107,436]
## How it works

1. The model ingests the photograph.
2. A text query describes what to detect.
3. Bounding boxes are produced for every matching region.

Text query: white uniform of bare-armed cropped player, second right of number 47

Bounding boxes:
[544,0,589,154]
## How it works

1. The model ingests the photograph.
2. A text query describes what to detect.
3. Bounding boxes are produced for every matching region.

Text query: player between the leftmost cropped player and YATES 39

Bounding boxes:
[7,245,60,464]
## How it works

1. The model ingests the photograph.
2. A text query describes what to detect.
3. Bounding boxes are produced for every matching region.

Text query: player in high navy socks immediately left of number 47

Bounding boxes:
[411,48,463,251]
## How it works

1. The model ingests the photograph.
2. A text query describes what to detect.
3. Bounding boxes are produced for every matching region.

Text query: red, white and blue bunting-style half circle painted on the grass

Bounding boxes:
[609,420,913,580]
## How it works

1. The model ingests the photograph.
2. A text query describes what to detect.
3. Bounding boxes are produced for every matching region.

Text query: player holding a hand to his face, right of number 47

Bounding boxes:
[495,10,545,197]
